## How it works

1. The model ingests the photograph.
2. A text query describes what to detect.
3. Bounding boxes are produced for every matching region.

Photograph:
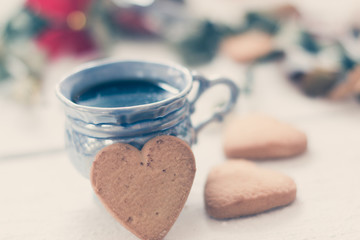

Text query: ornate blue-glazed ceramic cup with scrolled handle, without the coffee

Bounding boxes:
[56,60,239,178]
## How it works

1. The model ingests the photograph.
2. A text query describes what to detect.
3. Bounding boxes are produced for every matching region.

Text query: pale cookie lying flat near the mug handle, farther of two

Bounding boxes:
[224,114,307,159]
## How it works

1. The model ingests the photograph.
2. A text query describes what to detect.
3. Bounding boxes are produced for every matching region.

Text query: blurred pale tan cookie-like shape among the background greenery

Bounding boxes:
[220,31,274,62]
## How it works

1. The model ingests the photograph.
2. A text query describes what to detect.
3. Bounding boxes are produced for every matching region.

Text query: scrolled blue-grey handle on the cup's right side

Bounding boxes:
[190,73,240,136]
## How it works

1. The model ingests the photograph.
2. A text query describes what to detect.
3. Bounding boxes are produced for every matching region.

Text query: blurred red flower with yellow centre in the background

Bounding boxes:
[26,0,96,59]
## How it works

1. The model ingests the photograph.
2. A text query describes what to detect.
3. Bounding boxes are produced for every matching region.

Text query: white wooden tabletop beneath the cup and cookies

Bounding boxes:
[0,1,360,240]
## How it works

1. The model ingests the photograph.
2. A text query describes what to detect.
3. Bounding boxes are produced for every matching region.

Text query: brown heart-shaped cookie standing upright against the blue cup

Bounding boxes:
[91,136,196,240]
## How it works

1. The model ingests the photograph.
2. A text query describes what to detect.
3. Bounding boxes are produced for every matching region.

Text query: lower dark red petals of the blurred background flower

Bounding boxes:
[36,28,96,59]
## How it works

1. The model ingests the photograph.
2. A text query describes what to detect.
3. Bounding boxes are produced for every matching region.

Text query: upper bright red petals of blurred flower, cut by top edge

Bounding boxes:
[26,0,91,22]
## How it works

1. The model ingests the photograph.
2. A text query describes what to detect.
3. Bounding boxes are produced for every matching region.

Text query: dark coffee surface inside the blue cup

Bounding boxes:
[72,79,178,108]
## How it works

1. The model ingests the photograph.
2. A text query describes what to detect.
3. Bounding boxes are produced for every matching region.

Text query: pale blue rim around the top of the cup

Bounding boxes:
[55,58,192,112]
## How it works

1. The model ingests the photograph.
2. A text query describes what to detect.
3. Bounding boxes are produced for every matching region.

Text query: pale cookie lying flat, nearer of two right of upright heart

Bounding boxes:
[205,160,296,219]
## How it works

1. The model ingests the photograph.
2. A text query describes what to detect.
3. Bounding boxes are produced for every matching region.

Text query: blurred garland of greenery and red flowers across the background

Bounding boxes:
[0,0,360,101]
